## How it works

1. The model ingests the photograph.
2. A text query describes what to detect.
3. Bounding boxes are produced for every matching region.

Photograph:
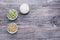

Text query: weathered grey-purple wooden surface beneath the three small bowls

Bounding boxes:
[0,0,60,40]
